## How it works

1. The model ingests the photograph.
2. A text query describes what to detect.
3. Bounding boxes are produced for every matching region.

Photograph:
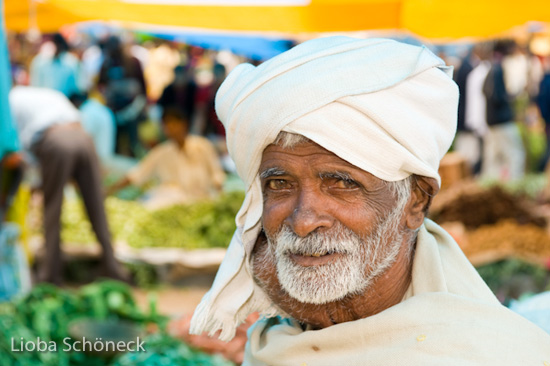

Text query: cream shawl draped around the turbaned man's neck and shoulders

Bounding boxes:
[243,220,550,366]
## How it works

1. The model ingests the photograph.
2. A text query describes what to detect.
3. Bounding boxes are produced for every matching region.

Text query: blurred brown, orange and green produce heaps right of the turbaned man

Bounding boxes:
[430,176,550,304]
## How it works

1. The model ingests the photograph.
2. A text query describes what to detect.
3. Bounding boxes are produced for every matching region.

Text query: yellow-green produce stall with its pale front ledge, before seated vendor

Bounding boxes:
[23,191,244,284]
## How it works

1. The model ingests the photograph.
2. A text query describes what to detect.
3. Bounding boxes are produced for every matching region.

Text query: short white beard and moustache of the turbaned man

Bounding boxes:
[267,202,406,304]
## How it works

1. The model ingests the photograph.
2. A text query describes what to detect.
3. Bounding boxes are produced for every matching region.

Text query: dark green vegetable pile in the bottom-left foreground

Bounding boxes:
[0,281,233,366]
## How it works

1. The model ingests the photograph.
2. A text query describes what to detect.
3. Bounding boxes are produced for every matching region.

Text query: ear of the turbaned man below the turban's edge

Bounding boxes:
[406,175,439,230]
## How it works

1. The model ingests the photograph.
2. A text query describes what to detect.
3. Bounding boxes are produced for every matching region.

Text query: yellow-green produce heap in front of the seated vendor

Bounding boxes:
[44,191,244,249]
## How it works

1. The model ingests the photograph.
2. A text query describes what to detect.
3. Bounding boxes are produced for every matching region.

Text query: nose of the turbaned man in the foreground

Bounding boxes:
[285,190,334,238]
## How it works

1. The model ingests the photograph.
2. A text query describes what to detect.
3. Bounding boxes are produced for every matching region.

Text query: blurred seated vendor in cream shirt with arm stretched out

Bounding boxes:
[109,108,225,209]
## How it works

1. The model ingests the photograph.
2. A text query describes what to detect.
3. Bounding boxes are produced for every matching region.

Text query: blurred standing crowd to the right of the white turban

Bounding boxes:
[448,40,550,181]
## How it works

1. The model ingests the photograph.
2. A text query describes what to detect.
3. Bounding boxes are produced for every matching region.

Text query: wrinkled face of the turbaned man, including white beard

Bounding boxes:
[260,142,406,304]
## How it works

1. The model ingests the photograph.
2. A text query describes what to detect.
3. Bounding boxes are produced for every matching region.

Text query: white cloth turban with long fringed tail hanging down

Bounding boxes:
[191,37,458,340]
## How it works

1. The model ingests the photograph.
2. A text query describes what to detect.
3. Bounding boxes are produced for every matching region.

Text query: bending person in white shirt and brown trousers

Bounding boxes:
[9,86,128,284]
